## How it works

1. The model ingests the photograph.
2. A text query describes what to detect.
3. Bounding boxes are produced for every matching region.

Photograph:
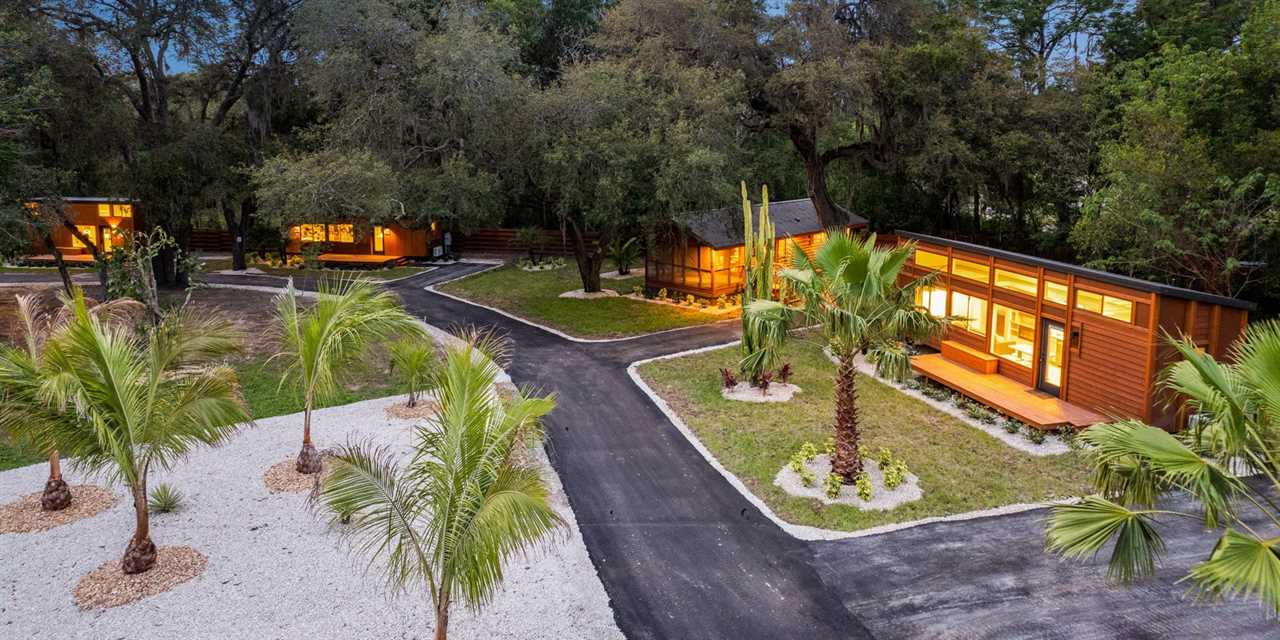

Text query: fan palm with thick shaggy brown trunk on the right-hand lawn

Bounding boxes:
[746,234,946,483]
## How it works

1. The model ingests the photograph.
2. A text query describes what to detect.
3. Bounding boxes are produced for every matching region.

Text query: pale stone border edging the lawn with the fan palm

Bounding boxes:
[627,340,1079,540]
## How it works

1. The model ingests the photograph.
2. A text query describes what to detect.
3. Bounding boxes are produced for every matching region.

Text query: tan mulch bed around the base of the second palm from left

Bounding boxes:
[76,547,209,609]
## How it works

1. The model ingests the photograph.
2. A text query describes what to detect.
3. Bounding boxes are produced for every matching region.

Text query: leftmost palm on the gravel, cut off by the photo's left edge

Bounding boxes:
[0,289,145,511]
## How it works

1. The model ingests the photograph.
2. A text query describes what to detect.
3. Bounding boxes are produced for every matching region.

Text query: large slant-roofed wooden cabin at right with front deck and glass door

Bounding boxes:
[899,232,1254,430]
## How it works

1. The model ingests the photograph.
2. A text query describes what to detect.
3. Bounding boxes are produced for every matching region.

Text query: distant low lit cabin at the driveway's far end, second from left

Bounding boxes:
[284,221,440,265]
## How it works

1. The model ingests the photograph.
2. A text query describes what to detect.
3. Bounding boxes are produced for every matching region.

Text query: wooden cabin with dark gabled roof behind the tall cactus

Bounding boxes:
[644,198,867,298]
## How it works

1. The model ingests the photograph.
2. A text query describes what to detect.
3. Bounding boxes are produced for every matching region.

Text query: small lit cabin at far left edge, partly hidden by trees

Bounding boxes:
[27,197,137,262]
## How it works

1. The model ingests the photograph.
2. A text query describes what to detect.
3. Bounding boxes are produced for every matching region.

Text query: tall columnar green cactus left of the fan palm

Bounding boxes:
[739,182,786,385]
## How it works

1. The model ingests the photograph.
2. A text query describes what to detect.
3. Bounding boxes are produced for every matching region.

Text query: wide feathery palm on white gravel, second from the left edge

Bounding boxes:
[41,293,248,573]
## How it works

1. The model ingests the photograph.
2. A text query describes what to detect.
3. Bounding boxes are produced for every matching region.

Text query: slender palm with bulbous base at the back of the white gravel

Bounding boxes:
[271,278,425,474]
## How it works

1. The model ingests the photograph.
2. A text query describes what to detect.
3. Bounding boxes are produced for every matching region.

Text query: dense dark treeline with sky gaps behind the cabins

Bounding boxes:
[0,0,1280,300]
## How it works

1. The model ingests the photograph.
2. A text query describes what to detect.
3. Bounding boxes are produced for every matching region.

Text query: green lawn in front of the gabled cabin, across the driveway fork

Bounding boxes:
[440,264,724,338]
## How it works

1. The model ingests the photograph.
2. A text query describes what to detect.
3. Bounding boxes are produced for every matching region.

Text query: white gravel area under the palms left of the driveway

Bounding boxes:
[0,397,622,640]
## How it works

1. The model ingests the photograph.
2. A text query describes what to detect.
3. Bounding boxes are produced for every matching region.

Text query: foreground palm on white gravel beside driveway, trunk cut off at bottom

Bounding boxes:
[320,332,563,640]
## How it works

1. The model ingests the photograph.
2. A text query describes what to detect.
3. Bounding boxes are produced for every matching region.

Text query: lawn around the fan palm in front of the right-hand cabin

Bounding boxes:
[640,340,1089,531]
